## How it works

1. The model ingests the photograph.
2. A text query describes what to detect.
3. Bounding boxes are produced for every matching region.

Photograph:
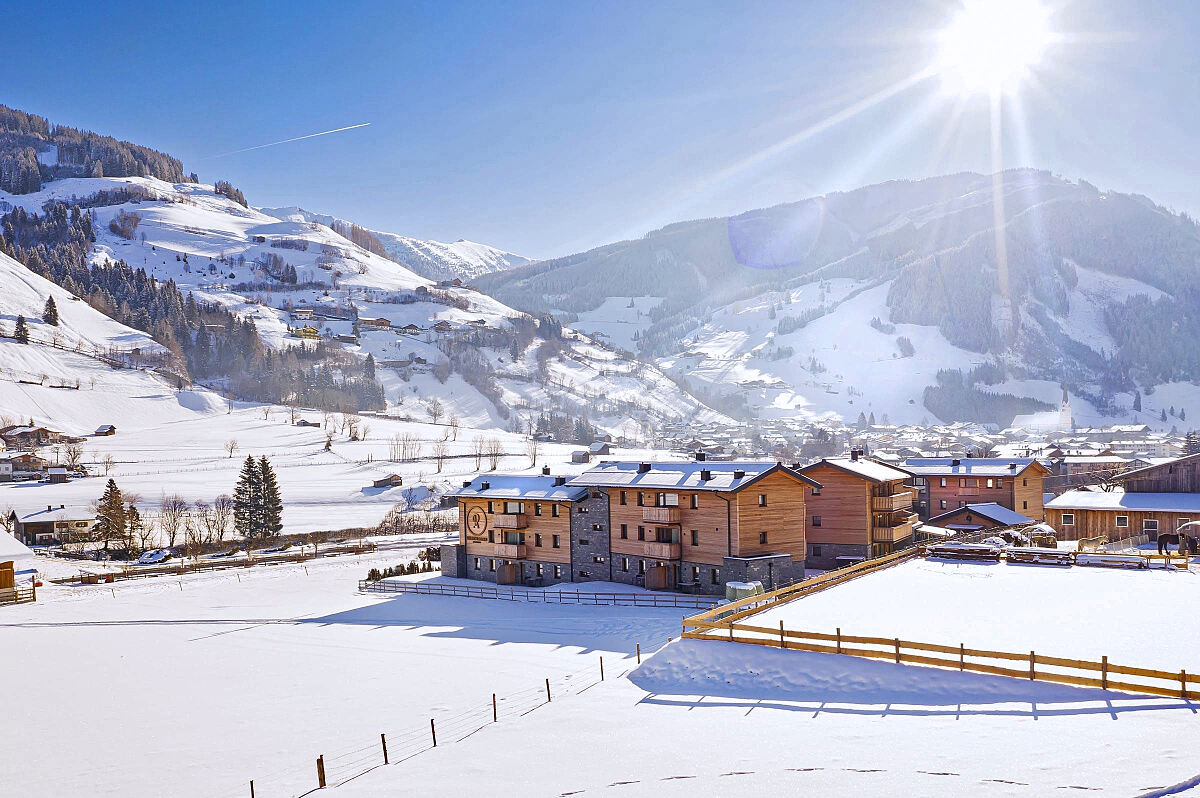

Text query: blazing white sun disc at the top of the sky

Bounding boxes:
[936,0,1052,94]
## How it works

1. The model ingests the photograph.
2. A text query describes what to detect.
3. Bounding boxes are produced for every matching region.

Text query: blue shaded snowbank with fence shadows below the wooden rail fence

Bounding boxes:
[629,640,1200,720]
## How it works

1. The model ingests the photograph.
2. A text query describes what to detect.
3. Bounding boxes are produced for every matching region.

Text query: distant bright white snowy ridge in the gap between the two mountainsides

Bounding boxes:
[259,205,532,281]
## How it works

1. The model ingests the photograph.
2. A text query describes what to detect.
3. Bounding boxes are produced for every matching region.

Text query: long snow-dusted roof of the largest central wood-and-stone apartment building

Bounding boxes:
[571,460,821,492]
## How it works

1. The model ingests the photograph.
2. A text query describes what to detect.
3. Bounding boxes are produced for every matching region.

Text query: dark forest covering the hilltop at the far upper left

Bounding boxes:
[0,106,186,194]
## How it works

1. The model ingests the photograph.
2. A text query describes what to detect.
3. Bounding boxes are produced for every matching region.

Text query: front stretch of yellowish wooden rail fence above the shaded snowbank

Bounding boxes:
[683,612,1200,698]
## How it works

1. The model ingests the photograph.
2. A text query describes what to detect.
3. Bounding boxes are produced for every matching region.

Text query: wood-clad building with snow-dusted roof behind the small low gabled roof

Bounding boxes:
[898,457,1050,521]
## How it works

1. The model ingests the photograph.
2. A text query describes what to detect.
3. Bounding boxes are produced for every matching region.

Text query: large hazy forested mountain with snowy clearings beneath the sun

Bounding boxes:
[475,169,1200,425]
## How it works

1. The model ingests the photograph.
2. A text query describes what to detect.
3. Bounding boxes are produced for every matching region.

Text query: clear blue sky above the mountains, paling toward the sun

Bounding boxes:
[0,0,1200,257]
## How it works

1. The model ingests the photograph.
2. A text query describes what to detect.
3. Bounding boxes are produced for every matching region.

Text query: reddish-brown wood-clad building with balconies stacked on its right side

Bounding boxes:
[799,451,917,569]
